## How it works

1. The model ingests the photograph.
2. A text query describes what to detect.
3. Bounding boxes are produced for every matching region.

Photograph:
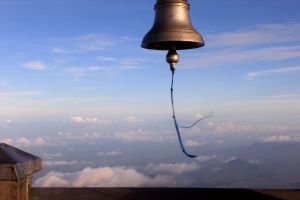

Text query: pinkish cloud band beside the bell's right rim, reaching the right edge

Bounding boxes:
[206,23,300,47]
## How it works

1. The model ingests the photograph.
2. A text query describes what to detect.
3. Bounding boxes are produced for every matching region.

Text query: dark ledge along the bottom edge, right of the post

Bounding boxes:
[30,188,300,200]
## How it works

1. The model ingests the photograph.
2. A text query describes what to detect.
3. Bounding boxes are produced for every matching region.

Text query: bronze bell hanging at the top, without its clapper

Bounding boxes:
[141,0,204,51]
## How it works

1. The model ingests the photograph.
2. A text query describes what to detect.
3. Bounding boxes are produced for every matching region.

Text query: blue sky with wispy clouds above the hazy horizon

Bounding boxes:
[0,1,299,119]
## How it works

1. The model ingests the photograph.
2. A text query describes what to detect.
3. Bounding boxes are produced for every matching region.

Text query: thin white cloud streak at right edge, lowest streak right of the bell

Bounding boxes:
[244,66,300,80]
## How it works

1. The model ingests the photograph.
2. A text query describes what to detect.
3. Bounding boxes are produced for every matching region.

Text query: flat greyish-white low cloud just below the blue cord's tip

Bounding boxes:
[146,162,199,174]
